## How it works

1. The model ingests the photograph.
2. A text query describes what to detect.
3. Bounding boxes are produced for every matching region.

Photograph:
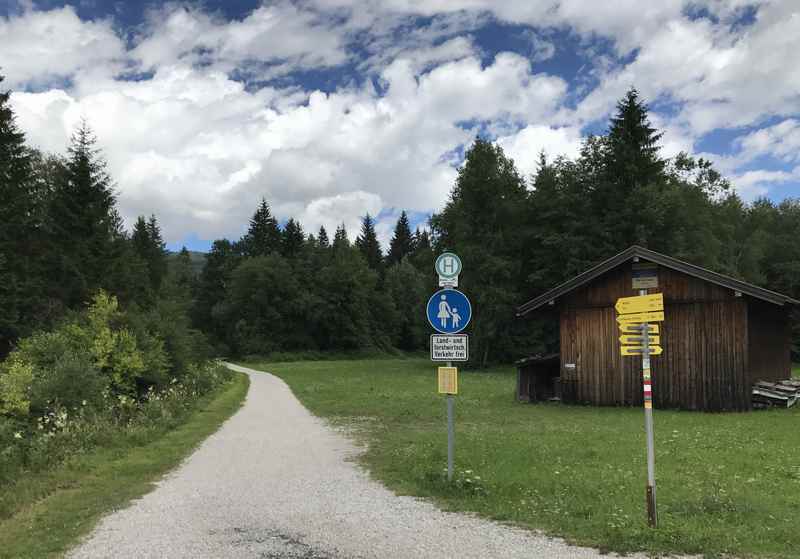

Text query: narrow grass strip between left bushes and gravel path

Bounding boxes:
[0,374,249,559]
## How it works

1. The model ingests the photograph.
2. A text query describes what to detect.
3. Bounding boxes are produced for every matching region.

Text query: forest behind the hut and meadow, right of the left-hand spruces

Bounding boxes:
[193,89,800,365]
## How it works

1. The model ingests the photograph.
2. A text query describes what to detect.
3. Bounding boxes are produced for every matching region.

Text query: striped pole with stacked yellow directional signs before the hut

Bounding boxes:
[614,288,664,527]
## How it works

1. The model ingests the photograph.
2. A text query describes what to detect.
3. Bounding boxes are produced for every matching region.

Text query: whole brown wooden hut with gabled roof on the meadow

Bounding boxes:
[517,246,800,411]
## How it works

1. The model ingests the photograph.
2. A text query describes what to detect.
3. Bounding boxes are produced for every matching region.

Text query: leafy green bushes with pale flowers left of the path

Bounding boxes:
[0,291,232,490]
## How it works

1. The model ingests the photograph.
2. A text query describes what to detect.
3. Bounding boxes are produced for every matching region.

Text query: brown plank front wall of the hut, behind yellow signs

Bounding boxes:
[559,266,750,410]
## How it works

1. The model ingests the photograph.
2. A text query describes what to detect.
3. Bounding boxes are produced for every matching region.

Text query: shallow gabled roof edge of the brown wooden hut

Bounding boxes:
[517,245,800,316]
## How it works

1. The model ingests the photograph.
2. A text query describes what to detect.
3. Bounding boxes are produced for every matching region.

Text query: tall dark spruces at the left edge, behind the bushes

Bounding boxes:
[0,76,209,368]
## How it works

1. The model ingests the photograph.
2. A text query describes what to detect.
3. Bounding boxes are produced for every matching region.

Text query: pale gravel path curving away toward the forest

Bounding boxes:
[69,365,656,559]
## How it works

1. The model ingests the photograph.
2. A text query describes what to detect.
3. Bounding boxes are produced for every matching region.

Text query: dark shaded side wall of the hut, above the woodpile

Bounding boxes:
[748,300,792,385]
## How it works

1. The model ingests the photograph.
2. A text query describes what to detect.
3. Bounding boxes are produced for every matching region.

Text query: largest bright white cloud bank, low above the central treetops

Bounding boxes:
[12,54,566,242]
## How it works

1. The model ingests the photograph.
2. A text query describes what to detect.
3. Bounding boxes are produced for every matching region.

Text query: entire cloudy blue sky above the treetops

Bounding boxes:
[0,0,800,249]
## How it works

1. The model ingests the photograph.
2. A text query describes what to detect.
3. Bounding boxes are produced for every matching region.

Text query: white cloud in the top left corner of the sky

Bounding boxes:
[0,6,125,87]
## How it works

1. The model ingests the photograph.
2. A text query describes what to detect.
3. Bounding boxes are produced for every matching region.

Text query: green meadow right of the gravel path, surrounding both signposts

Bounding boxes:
[242,359,800,558]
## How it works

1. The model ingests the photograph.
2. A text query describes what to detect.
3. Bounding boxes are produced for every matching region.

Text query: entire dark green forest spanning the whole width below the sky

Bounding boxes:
[0,73,800,365]
